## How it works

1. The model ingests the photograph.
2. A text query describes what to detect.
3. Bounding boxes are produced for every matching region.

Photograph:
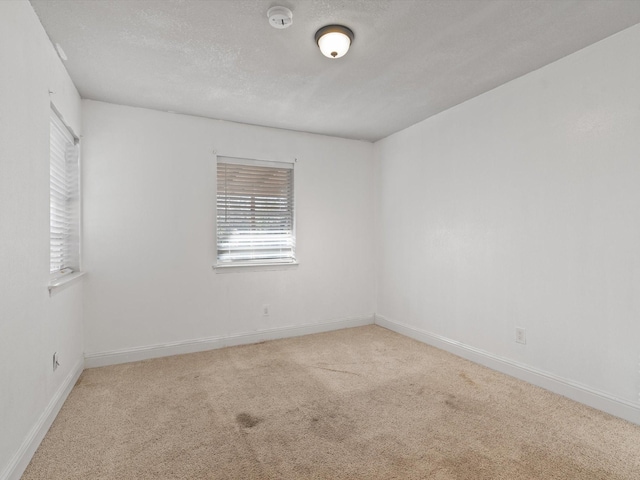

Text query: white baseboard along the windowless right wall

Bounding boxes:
[374,314,640,425]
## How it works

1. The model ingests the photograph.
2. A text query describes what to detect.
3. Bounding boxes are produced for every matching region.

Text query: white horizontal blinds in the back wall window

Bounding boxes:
[217,157,295,264]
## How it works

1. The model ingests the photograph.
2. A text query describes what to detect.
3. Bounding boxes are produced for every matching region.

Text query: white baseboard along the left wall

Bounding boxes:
[0,359,84,480]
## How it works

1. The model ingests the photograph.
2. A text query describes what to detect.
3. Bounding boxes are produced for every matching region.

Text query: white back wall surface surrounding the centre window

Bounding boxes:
[82,100,374,355]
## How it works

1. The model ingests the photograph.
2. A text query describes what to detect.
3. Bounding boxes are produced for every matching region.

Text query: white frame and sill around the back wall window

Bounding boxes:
[212,154,298,273]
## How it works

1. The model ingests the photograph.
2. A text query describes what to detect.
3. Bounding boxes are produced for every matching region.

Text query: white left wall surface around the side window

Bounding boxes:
[0,1,83,479]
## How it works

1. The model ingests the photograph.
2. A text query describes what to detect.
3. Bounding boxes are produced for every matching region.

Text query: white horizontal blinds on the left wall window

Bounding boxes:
[49,111,79,274]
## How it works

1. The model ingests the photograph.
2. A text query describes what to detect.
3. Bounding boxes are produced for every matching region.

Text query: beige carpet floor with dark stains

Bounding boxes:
[23,326,640,480]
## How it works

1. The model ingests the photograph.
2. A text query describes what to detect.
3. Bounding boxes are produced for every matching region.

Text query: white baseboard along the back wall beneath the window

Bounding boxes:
[85,315,373,370]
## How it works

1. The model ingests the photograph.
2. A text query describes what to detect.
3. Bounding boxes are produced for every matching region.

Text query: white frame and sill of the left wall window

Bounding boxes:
[48,104,83,286]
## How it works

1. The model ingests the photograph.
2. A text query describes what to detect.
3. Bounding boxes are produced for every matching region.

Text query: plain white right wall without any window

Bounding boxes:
[374,26,640,406]
